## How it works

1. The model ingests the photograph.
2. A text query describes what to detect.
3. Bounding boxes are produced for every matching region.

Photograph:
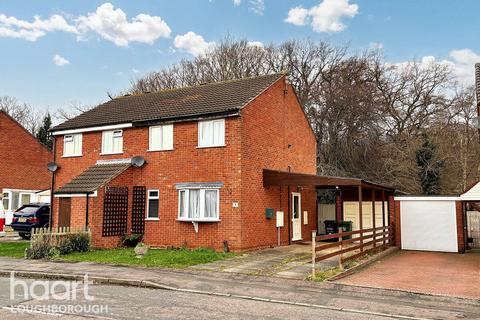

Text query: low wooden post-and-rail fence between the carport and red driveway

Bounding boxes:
[312,226,394,276]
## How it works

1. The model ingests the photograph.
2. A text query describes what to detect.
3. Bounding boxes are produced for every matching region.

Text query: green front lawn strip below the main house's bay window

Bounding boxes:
[58,248,234,268]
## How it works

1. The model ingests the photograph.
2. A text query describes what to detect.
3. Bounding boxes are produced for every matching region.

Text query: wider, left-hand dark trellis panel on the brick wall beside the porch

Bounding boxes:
[102,187,128,237]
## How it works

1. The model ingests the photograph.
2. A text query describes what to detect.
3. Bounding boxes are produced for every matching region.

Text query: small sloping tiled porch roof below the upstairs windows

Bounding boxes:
[55,162,131,194]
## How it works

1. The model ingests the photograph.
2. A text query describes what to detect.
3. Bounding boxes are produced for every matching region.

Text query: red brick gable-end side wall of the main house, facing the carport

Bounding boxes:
[241,80,317,248]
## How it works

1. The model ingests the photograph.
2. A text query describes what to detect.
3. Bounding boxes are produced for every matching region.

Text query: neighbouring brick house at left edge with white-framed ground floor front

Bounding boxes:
[0,111,51,225]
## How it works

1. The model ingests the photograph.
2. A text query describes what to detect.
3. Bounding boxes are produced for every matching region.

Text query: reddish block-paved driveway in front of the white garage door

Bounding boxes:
[336,251,480,299]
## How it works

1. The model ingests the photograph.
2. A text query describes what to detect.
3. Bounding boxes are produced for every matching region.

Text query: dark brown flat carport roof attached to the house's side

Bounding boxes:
[263,169,394,192]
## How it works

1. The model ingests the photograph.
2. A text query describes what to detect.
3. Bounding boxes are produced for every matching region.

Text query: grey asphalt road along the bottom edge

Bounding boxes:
[0,278,416,320]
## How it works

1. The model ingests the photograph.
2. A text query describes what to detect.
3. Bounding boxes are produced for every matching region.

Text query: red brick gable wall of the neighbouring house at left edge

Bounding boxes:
[0,111,51,191]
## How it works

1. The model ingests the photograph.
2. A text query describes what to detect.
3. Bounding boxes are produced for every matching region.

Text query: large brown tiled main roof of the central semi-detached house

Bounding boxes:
[52,74,284,131]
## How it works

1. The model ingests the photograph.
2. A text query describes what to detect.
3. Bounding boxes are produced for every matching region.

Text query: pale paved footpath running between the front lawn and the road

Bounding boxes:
[0,258,480,319]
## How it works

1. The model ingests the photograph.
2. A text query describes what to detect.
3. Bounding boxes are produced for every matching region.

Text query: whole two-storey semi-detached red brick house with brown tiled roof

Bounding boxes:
[52,74,317,251]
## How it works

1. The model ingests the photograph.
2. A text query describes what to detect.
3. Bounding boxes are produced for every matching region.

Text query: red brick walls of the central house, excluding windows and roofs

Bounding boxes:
[53,78,317,251]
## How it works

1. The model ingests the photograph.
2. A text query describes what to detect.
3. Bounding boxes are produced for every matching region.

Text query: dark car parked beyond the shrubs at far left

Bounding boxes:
[11,202,50,240]
